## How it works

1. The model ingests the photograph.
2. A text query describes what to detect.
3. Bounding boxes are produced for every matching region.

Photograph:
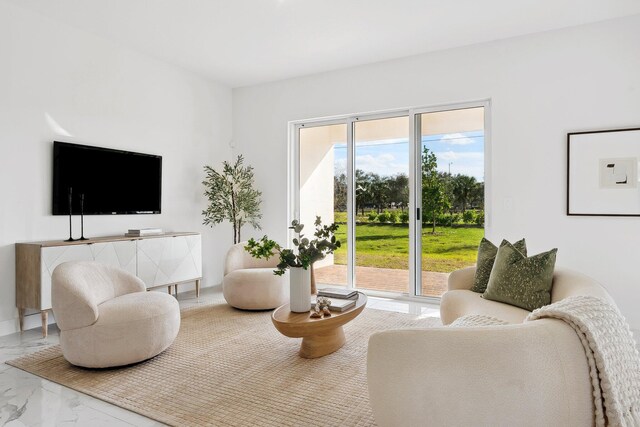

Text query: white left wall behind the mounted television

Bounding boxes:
[0,2,232,335]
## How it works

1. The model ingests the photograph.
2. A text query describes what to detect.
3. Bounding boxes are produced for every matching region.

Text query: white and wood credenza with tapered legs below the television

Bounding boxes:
[16,233,202,337]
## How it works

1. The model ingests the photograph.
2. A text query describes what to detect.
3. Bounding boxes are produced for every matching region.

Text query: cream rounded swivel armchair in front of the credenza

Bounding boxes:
[51,261,180,368]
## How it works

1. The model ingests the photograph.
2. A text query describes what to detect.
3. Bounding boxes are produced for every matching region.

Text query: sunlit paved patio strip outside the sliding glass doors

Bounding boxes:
[315,264,449,298]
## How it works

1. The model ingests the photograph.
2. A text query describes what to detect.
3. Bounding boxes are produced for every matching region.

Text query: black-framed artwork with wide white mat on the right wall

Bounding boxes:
[567,128,640,216]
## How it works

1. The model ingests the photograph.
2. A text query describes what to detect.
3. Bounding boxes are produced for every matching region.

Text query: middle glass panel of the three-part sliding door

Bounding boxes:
[353,115,410,293]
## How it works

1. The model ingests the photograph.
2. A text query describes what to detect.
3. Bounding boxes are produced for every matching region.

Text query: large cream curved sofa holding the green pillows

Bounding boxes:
[367,267,613,427]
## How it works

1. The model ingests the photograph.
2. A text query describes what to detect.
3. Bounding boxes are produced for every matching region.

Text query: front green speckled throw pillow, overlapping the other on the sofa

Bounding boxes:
[482,242,558,311]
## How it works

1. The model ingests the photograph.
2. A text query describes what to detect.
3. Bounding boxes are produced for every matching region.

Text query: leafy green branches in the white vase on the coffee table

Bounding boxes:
[245,216,340,298]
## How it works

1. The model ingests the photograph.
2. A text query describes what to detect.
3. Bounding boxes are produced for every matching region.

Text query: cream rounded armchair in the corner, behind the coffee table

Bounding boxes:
[222,242,289,310]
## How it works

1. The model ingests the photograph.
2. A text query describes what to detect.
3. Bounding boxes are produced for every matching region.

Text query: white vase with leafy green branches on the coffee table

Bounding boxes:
[245,216,340,312]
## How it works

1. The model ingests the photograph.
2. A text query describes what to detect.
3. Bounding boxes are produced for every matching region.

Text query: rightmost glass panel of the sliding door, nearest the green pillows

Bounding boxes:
[415,106,485,297]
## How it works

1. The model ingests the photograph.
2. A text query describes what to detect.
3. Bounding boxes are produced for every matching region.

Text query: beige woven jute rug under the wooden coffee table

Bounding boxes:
[7,303,440,426]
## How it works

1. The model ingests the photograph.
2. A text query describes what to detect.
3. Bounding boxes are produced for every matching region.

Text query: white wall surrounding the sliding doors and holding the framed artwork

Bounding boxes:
[233,16,640,329]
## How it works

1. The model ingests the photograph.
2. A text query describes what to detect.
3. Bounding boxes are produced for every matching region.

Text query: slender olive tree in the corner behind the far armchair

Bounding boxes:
[202,156,262,244]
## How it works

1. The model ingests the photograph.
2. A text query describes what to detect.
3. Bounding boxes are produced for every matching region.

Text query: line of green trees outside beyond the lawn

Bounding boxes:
[333,147,484,231]
